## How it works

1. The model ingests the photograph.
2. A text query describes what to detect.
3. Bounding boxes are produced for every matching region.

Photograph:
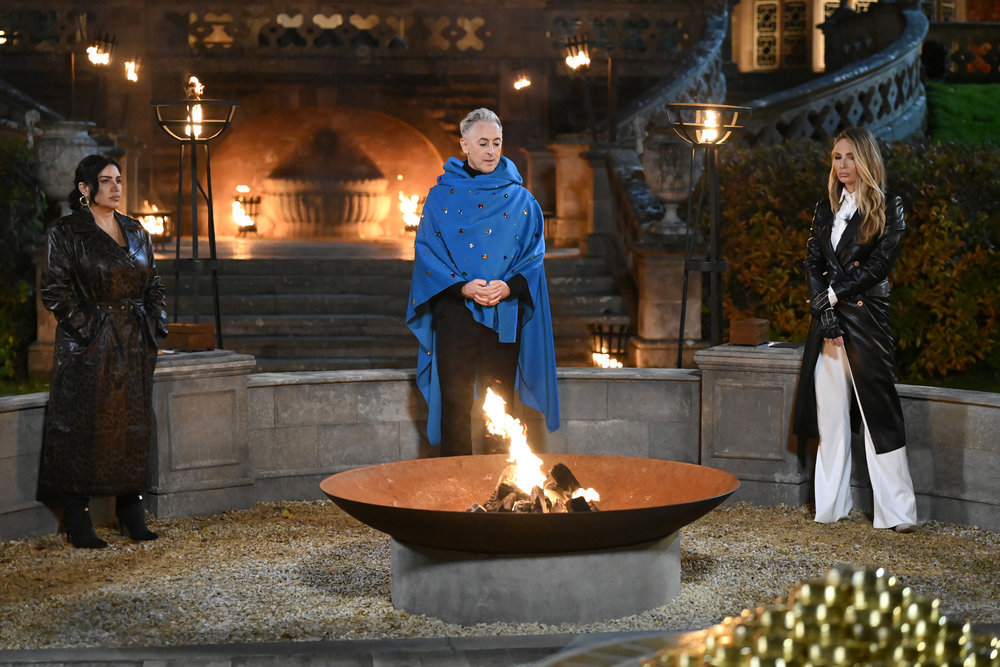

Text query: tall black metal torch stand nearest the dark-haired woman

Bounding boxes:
[153,76,239,349]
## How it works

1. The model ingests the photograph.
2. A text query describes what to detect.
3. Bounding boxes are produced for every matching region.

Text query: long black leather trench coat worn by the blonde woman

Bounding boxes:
[794,196,906,454]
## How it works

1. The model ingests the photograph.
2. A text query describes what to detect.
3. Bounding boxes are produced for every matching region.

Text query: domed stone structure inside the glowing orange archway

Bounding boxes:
[261,129,391,239]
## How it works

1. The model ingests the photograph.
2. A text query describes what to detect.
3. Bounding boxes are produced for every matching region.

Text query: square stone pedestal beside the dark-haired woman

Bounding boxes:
[148,350,256,518]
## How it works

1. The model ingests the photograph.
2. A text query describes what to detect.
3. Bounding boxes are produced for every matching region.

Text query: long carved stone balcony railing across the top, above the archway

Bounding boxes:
[0,0,703,76]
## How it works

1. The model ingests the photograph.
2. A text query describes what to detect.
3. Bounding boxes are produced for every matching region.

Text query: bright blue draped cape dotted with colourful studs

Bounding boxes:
[406,157,559,445]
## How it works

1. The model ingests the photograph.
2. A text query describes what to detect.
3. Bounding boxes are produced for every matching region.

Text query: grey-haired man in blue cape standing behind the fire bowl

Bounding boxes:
[406,109,559,456]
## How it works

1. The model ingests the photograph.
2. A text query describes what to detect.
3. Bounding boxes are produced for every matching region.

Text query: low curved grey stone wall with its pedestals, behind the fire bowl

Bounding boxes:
[0,344,1000,540]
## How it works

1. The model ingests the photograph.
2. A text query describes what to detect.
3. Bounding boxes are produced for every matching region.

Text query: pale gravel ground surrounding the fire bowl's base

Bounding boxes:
[0,501,1000,649]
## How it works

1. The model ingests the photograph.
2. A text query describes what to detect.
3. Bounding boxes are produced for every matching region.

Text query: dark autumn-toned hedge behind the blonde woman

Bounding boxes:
[720,142,1000,383]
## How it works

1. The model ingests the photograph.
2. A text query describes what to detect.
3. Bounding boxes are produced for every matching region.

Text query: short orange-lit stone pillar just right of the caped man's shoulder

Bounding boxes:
[548,136,594,248]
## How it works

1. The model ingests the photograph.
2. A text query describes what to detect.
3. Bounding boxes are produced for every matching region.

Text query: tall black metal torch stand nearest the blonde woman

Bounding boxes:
[666,103,750,368]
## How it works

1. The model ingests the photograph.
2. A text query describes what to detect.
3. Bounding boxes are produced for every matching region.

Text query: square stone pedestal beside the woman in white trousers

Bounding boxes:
[694,343,810,507]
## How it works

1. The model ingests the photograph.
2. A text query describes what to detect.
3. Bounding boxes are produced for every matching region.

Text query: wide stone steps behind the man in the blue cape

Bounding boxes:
[157,256,628,372]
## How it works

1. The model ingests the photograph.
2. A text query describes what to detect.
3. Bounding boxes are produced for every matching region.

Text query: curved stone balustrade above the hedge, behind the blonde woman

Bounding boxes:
[743,10,928,146]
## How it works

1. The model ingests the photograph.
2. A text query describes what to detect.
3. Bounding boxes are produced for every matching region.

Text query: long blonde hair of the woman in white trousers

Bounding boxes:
[828,127,885,243]
